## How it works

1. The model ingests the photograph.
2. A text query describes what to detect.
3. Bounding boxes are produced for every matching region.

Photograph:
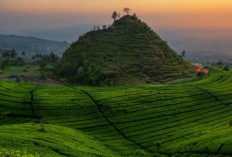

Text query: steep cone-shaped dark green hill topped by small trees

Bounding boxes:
[55,16,191,86]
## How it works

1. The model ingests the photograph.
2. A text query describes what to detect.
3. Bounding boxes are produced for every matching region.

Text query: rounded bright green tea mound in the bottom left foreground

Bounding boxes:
[0,124,116,157]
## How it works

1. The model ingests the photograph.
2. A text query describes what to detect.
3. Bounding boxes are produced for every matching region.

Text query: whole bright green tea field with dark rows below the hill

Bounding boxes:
[0,68,232,157]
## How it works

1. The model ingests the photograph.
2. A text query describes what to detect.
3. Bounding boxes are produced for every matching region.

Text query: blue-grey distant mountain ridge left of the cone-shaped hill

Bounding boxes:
[0,35,70,56]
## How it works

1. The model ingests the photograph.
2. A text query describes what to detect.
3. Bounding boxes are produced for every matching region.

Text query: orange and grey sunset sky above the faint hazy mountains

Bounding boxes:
[0,0,232,30]
